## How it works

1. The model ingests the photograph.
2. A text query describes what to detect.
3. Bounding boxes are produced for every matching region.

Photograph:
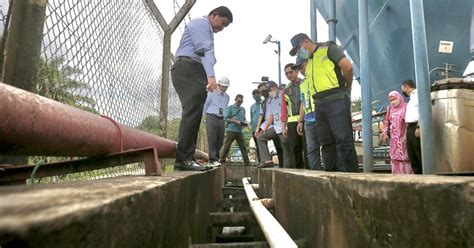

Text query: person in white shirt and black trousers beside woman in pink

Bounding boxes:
[402,79,423,174]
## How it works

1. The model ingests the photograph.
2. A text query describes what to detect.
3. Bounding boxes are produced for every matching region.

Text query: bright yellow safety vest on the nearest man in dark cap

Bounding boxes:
[305,44,340,95]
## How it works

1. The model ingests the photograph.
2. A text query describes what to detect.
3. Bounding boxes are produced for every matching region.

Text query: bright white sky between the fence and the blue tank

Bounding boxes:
[161,0,360,119]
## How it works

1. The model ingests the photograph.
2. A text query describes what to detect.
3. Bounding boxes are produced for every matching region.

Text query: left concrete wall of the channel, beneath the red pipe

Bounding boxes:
[0,169,223,248]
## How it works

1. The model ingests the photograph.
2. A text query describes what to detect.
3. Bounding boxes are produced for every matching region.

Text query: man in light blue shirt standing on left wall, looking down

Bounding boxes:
[171,6,233,171]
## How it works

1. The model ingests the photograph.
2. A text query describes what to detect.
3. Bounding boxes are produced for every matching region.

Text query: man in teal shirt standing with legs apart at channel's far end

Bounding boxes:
[221,94,250,166]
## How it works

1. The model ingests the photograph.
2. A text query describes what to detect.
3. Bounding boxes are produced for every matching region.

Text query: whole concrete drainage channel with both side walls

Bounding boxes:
[0,165,474,248]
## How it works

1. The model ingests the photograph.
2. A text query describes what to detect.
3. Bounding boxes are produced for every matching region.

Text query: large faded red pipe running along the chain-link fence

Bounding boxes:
[0,83,208,160]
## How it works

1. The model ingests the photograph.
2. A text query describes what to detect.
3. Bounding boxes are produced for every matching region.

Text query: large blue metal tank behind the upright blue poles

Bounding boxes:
[313,0,473,104]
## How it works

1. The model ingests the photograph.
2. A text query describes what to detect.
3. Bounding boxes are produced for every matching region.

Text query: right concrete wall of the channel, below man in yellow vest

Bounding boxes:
[259,169,474,248]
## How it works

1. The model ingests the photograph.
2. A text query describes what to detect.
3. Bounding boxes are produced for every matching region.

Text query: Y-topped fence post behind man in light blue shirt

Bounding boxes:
[143,0,196,138]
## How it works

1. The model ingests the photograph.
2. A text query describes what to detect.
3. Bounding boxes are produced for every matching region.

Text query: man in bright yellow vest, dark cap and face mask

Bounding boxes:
[290,33,358,172]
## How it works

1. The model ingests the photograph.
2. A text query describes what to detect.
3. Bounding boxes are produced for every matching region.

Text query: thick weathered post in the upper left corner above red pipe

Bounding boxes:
[2,0,47,91]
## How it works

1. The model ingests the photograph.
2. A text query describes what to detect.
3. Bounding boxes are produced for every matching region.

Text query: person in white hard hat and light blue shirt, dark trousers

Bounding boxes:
[204,77,230,167]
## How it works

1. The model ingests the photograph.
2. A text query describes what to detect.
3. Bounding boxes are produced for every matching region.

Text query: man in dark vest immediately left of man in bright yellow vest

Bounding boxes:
[284,63,308,169]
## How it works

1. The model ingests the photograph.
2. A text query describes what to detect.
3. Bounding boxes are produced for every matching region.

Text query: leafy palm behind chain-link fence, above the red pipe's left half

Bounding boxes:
[35,56,98,114]
